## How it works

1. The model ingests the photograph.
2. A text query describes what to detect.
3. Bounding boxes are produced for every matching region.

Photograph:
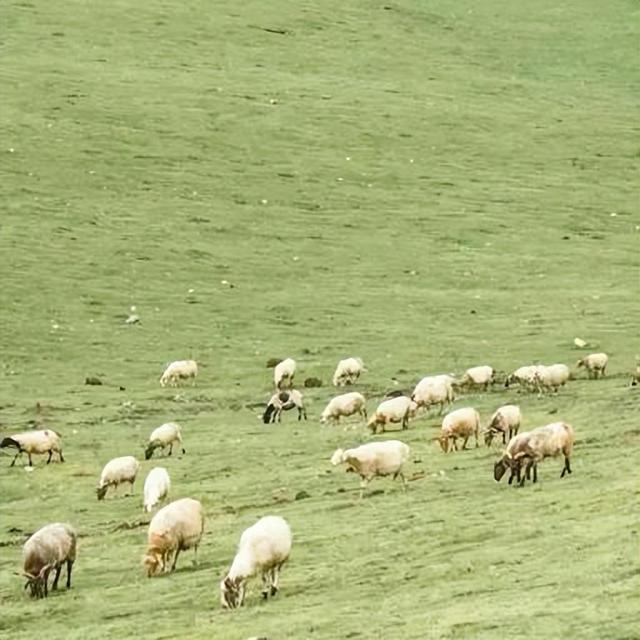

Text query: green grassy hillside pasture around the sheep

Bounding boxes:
[0,0,640,640]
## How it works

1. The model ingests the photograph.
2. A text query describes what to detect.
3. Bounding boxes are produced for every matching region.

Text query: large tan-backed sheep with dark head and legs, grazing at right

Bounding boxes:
[494,422,575,486]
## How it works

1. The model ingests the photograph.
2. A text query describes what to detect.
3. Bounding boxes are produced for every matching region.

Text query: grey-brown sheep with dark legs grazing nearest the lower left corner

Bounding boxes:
[22,522,77,598]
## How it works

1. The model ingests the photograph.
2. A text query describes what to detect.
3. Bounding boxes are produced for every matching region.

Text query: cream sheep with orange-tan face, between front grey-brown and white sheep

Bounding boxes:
[142,498,204,578]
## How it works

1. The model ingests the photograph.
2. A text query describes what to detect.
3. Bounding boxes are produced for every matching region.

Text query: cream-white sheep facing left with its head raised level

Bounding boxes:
[331,440,411,499]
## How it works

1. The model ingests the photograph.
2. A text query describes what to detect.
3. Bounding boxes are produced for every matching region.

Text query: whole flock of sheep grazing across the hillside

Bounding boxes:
[0,353,639,609]
